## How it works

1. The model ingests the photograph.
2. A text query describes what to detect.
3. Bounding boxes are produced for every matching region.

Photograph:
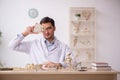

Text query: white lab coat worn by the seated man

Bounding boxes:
[9,34,72,67]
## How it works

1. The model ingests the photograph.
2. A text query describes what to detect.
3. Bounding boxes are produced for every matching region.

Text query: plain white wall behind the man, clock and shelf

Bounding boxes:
[0,0,120,79]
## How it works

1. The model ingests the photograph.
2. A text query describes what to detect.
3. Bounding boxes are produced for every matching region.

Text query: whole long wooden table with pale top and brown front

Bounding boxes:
[0,70,117,80]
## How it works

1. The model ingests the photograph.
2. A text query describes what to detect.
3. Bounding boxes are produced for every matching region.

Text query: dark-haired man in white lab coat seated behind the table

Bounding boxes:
[9,17,73,68]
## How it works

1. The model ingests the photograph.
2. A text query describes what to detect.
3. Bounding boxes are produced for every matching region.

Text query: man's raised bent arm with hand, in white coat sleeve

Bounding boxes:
[8,26,34,53]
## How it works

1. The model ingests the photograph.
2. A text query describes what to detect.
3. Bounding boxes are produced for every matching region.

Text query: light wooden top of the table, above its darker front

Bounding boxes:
[0,69,118,75]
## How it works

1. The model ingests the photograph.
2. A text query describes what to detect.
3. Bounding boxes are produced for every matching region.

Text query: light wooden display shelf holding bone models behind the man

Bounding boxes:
[70,7,96,67]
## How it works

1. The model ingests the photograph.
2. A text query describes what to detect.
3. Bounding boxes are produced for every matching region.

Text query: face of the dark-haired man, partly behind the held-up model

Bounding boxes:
[41,23,55,40]
